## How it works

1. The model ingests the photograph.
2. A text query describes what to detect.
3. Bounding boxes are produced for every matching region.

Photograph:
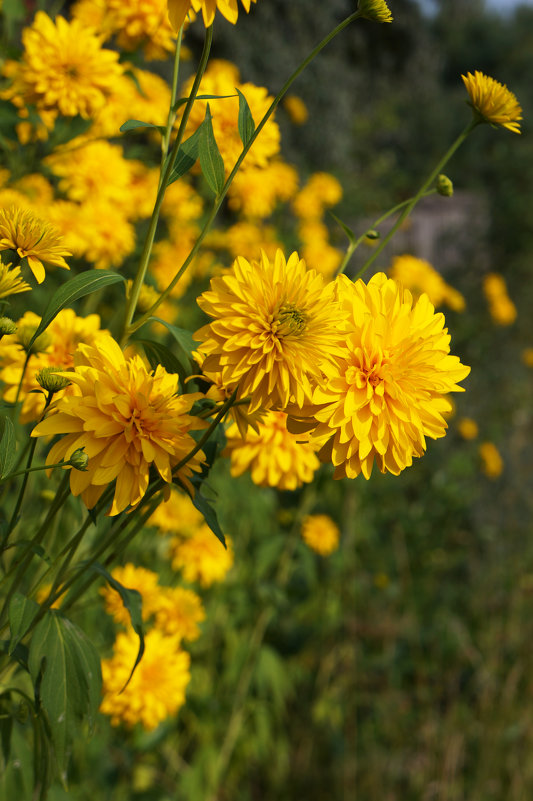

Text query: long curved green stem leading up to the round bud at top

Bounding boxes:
[124,11,361,339]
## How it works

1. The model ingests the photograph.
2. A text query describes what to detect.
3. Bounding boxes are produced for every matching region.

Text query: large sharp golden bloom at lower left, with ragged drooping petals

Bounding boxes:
[32,336,205,515]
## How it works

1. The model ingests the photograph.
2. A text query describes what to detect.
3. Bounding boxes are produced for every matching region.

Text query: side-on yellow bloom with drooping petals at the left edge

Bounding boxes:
[0,206,72,284]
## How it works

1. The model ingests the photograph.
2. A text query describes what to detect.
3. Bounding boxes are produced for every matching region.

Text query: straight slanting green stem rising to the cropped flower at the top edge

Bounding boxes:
[121,25,213,345]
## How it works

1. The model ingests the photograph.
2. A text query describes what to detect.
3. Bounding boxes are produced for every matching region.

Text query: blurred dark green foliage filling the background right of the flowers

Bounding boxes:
[3,0,533,801]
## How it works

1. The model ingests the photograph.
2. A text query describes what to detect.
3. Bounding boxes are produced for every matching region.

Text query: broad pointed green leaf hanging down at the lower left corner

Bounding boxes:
[29,611,102,787]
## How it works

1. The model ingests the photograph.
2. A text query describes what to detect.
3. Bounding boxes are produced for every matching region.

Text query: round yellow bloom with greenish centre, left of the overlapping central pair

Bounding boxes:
[194,250,343,412]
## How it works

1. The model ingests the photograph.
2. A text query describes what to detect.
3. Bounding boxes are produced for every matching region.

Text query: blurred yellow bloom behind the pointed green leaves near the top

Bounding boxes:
[180,60,281,174]
